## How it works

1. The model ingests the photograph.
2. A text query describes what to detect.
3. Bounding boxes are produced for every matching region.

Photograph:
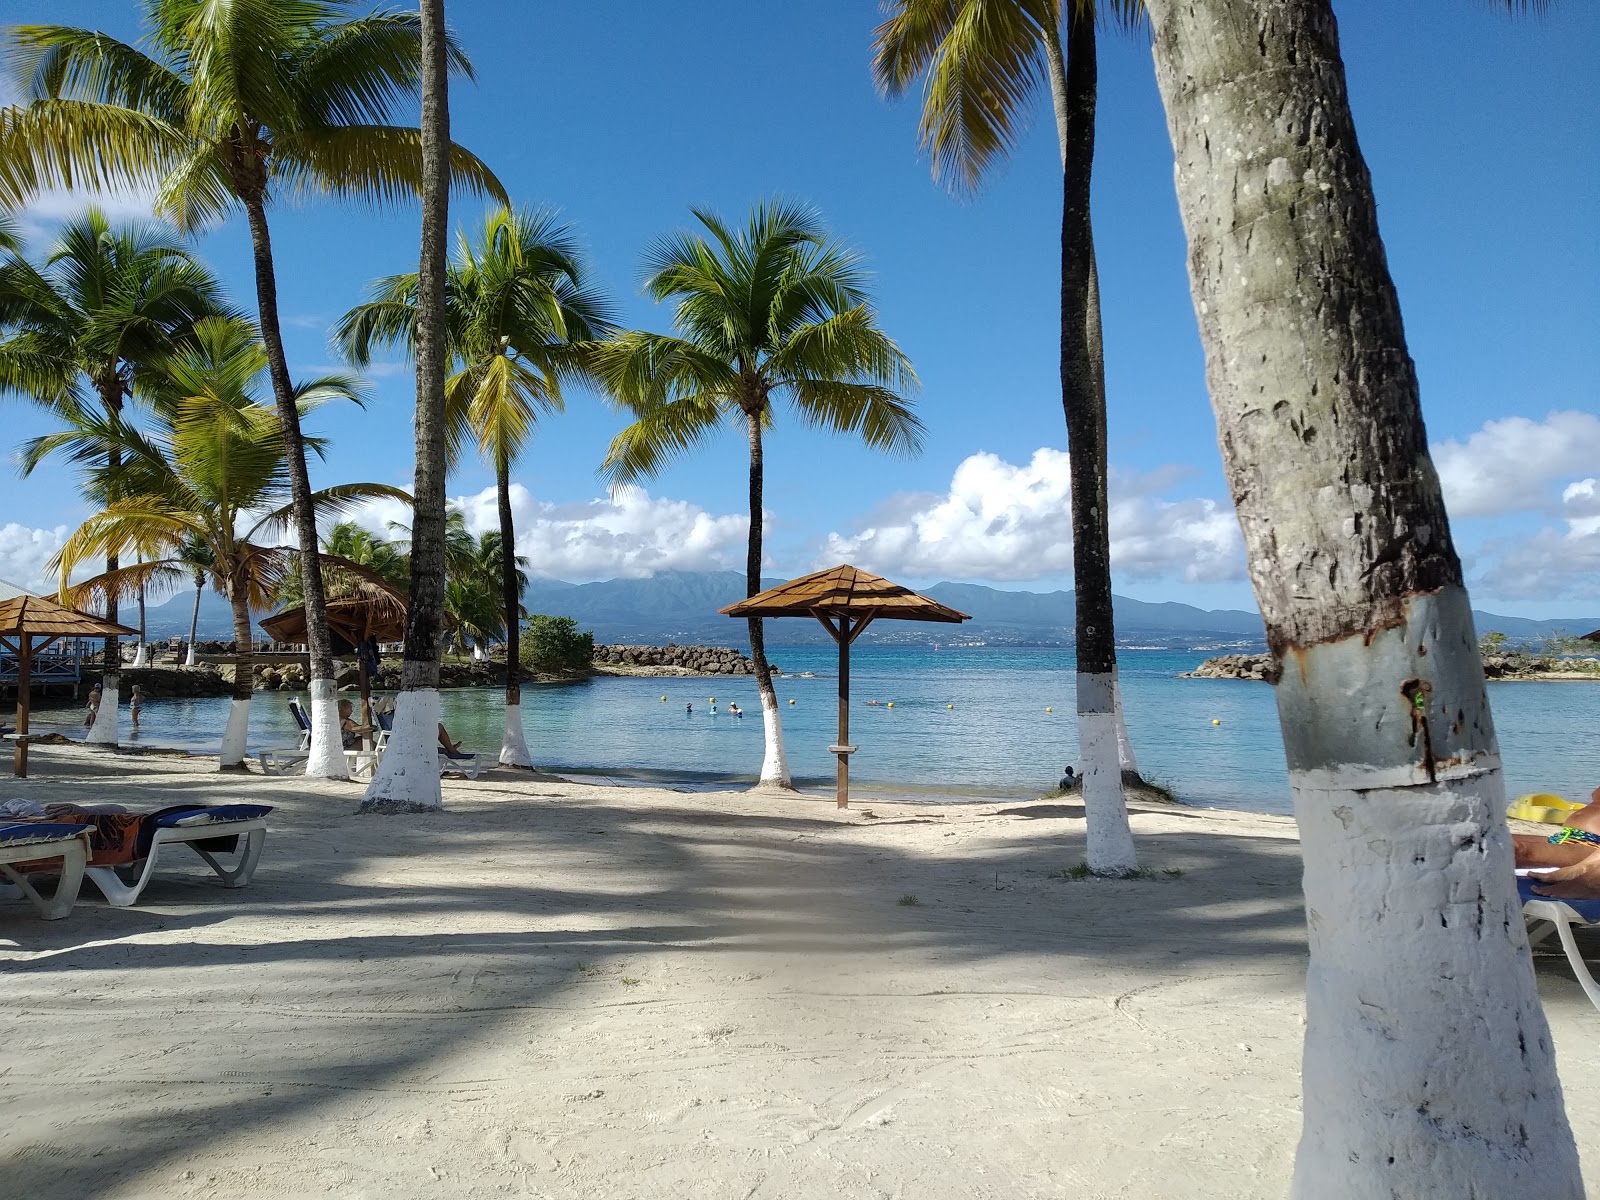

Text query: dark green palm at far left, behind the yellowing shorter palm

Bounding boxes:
[0,208,224,746]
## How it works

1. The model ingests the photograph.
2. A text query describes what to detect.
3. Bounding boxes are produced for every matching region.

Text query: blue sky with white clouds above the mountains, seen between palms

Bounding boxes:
[0,0,1600,616]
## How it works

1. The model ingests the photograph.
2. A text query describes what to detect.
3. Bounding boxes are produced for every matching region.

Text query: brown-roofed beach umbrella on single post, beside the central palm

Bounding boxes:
[717,566,971,808]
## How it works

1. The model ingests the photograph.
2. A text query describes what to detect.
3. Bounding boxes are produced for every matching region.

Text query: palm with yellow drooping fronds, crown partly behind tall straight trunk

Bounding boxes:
[334,208,610,766]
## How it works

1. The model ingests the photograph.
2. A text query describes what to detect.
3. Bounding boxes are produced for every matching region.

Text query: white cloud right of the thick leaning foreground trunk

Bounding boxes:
[1432,411,1600,518]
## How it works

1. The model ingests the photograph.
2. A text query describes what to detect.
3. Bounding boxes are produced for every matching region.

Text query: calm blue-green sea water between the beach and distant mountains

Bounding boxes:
[34,645,1600,813]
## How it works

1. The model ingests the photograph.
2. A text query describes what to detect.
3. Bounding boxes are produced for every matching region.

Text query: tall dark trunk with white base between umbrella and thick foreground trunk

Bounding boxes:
[1061,5,1139,875]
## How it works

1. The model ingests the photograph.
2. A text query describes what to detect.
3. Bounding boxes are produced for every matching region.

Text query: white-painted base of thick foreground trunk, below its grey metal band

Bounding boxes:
[1290,762,1582,1200]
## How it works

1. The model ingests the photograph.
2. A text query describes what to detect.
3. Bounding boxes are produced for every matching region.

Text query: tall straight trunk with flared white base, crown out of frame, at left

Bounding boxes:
[362,0,450,813]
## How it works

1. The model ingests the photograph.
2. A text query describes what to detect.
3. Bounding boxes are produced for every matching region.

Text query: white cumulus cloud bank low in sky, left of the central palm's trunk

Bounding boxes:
[354,483,749,582]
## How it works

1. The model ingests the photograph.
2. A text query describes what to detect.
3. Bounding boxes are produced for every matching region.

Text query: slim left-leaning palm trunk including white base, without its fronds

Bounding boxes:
[240,187,350,779]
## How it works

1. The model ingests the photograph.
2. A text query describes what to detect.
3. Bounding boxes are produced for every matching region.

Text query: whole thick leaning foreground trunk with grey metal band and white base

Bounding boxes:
[1147,0,1584,1200]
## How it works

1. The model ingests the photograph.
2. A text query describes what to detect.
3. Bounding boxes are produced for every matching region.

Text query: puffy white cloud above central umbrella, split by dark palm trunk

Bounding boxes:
[819,446,1245,582]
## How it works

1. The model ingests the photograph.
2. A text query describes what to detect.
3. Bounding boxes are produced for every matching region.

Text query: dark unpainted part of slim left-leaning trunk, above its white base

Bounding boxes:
[236,194,333,694]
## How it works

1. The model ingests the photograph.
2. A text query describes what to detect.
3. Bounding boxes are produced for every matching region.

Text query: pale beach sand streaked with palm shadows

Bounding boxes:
[0,747,1600,1200]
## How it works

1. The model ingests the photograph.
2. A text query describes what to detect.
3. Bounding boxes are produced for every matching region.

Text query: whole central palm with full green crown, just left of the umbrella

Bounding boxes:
[594,200,922,787]
